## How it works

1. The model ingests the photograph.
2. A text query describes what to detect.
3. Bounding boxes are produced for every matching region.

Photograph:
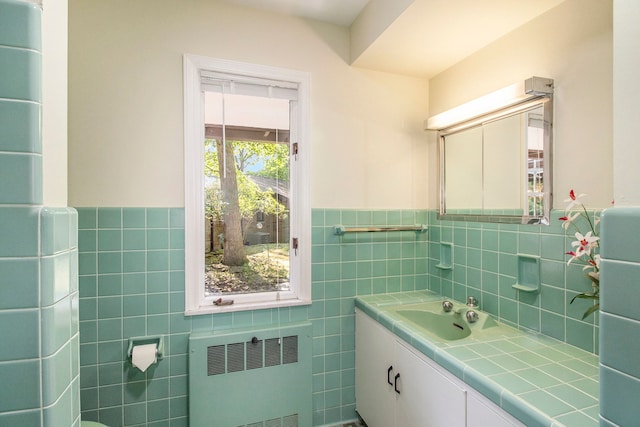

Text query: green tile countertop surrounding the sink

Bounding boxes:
[356,291,599,427]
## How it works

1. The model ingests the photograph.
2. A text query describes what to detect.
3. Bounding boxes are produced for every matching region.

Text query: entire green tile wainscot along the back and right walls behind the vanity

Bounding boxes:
[78,208,598,427]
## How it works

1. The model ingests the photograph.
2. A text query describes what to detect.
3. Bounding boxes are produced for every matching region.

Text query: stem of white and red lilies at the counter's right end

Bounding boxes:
[560,190,600,319]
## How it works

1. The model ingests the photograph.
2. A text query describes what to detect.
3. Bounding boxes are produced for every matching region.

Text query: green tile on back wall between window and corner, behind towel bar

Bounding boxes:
[309,209,428,426]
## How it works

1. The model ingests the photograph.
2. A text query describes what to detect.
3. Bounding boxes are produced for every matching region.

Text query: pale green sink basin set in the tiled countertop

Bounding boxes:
[384,301,510,341]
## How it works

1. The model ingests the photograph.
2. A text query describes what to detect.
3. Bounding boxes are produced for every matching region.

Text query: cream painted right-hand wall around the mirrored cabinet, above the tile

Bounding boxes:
[429,0,612,209]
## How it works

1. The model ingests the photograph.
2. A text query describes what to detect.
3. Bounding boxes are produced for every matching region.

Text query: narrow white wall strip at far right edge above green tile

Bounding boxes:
[613,0,640,207]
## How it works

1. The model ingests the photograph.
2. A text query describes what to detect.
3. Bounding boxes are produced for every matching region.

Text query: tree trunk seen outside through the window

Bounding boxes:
[216,141,247,266]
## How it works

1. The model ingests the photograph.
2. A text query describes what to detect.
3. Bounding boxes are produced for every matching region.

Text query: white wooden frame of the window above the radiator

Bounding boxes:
[183,54,311,315]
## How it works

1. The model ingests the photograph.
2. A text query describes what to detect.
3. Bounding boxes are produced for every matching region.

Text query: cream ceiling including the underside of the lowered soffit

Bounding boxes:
[227,0,564,78]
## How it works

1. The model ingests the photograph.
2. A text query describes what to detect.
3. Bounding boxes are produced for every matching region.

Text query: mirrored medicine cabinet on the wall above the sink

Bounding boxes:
[438,78,552,224]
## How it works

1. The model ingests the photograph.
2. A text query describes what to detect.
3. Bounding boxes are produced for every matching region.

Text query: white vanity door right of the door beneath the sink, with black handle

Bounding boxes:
[395,343,466,427]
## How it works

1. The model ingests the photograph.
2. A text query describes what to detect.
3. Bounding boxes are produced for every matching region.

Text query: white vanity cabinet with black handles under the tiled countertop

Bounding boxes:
[356,309,523,427]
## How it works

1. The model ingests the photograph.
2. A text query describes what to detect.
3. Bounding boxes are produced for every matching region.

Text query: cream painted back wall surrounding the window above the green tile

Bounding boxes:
[69,0,429,208]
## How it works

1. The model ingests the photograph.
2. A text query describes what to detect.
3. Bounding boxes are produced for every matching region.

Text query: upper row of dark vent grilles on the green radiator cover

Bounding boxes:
[207,335,298,376]
